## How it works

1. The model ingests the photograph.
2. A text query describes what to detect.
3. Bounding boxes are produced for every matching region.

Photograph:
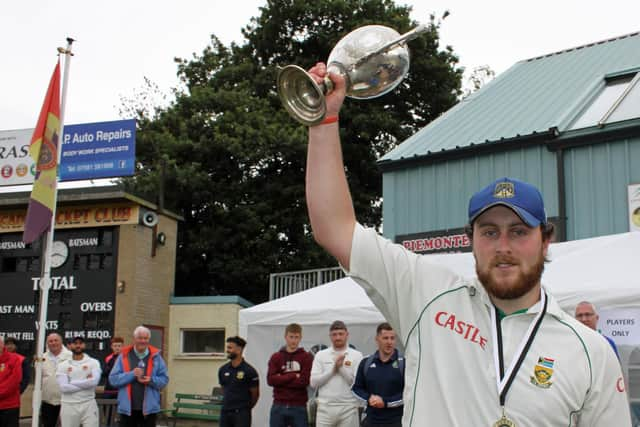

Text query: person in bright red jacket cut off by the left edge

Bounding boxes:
[0,336,22,427]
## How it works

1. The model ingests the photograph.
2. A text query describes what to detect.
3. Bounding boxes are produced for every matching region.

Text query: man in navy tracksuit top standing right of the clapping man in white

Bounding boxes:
[351,322,404,427]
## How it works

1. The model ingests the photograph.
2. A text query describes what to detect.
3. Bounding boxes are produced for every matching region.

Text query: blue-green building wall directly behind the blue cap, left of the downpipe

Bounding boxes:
[382,145,558,240]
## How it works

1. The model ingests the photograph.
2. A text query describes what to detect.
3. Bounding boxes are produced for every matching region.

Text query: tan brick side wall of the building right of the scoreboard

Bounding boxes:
[114,215,177,350]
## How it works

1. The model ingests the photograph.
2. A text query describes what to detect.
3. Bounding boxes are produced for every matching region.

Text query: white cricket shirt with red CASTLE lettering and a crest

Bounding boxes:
[347,224,631,427]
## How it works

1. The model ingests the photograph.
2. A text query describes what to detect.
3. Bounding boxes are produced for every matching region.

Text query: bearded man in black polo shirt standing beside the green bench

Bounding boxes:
[218,336,260,427]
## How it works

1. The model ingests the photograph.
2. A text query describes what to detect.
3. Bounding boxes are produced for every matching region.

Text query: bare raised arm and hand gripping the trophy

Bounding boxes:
[306,63,356,268]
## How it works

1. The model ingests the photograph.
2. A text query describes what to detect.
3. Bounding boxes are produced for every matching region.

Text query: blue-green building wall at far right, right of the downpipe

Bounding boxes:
[564,137,640,240]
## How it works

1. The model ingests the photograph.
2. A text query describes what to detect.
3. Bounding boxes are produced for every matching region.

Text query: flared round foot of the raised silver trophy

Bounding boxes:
[277,65,333,126]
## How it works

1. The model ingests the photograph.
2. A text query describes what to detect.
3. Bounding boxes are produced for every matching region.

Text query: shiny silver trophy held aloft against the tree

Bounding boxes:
[277,25,427,126]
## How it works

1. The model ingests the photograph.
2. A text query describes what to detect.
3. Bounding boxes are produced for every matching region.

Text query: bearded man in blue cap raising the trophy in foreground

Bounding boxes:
[294,24,631,427]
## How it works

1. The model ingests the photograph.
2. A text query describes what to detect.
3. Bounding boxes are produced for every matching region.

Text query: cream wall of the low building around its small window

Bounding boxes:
[166,304,243,405]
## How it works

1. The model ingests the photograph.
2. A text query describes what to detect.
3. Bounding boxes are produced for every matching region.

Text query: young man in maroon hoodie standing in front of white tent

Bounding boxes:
[267,323,313,427]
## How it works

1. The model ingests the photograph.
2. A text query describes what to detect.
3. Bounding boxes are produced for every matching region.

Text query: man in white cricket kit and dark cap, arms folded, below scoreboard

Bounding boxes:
[56,337,101,427]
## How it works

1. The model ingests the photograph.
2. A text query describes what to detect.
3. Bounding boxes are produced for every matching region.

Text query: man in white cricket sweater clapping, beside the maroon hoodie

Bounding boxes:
[311,320,362,427]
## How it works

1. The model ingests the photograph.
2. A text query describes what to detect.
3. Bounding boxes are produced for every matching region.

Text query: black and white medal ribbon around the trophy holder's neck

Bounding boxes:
[491,287,547,407]
